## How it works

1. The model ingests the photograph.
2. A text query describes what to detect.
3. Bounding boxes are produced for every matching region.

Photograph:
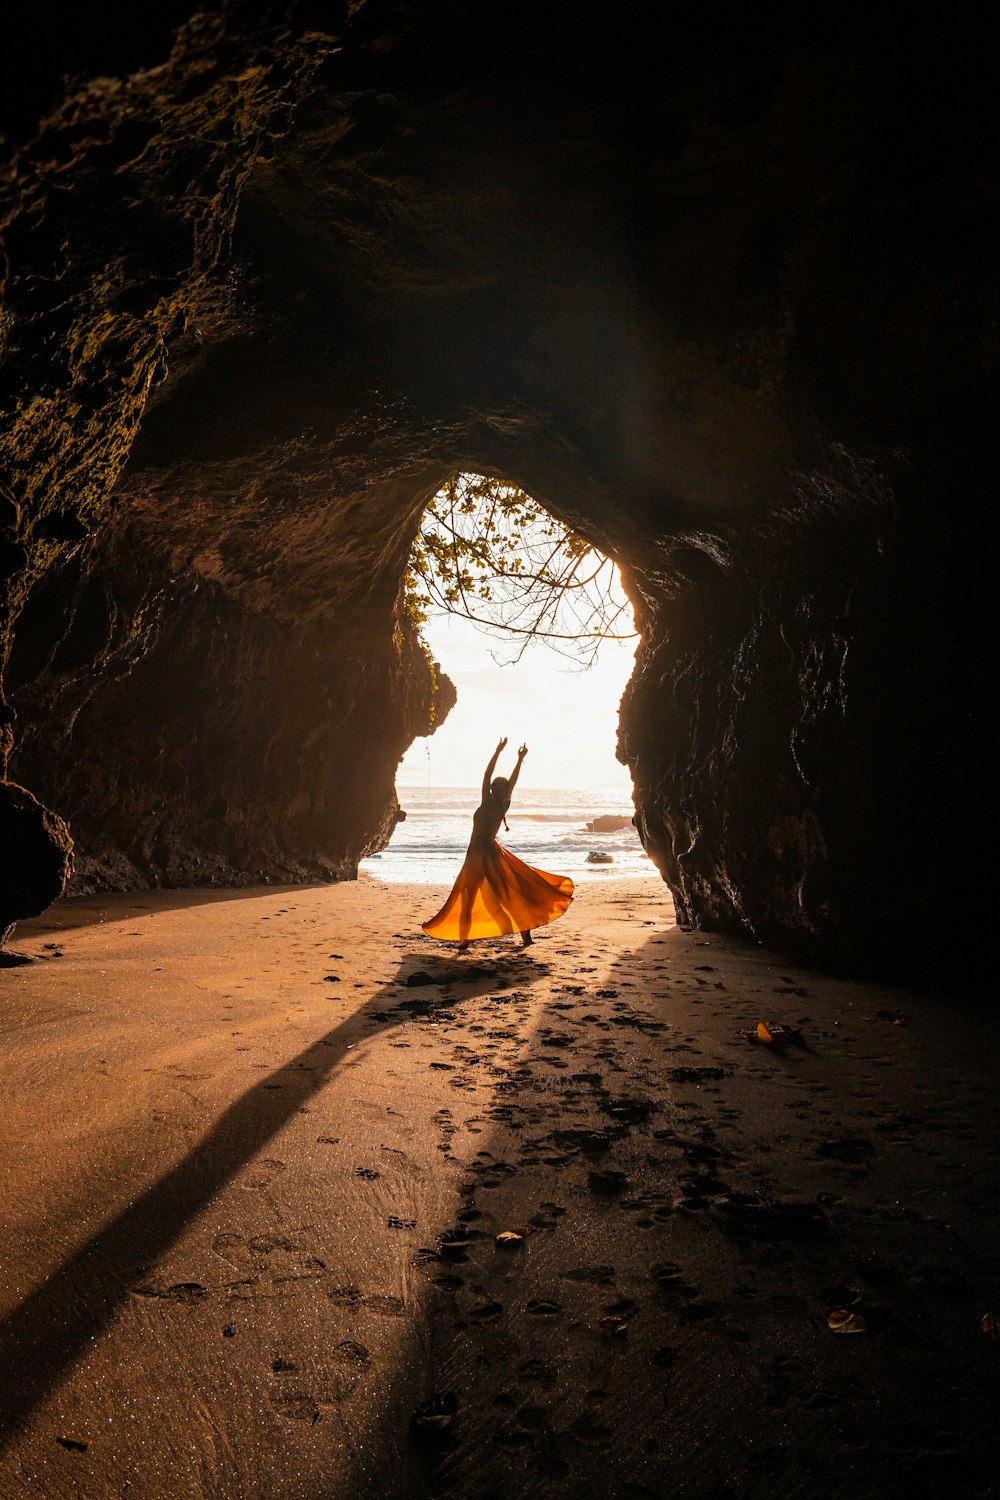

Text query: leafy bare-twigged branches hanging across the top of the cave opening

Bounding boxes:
[406,474,636,666]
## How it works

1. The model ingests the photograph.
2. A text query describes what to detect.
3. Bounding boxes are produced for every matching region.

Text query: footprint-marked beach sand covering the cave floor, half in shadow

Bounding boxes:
[0,876,1000,1500]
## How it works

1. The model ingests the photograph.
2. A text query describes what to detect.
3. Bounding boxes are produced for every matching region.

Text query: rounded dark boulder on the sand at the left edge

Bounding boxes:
[0,782,73,947]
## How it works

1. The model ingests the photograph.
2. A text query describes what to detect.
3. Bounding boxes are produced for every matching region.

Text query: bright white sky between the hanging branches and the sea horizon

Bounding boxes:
[396,591,637,792]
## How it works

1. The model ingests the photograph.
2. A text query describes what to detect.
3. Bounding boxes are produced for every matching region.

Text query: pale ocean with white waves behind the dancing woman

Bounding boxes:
[361,786,657,885]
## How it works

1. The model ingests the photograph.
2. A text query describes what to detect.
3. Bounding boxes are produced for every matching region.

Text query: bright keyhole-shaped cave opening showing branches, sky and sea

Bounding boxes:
[361,471,655,882]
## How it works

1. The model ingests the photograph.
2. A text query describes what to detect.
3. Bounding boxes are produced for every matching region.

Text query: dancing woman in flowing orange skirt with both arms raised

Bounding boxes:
[423,740,573,948]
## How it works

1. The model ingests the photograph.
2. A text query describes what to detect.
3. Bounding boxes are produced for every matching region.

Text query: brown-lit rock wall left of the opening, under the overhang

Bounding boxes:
[9,455,454,890]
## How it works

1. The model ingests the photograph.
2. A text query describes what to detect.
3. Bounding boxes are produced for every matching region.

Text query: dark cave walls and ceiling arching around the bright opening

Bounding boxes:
[0,0,993,963]
